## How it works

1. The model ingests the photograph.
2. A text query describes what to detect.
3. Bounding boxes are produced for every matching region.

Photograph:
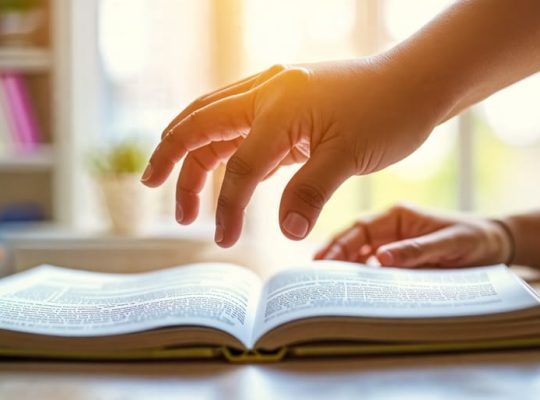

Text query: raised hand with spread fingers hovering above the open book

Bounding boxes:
[142,56,448,247]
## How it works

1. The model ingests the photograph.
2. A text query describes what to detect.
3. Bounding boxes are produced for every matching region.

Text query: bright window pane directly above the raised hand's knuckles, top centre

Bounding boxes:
[244,0,358,71]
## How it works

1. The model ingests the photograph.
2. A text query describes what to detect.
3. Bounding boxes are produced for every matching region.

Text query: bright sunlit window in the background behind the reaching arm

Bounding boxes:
[95,0,540,260]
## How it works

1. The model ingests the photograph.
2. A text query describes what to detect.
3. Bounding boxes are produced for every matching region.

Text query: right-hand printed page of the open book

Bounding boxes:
[252,261,539,342]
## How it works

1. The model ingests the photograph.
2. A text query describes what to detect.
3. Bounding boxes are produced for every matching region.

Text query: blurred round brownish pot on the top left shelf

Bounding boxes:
[0,0,43,45]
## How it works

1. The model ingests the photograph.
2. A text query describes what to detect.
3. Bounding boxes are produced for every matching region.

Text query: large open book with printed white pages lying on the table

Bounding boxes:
[0,261,540,361]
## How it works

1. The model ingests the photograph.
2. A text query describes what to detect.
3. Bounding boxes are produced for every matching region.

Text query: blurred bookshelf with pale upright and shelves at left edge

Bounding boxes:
[0,0,97,229]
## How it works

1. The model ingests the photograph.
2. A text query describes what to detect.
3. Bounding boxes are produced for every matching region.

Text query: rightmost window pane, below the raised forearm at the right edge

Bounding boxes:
[475,74,540,214]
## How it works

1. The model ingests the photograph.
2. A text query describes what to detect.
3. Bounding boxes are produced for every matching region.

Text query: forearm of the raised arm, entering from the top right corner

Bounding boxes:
[385,0,540,123]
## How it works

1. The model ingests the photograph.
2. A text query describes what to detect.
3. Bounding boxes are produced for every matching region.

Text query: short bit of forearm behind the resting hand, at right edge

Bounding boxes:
[501,211,540,268]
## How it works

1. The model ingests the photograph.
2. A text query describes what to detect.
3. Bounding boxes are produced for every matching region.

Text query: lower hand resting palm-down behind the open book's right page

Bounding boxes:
[315,206,513,268]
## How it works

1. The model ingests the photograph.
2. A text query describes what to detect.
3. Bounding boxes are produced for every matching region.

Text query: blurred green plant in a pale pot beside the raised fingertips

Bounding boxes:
[90,140,156,235]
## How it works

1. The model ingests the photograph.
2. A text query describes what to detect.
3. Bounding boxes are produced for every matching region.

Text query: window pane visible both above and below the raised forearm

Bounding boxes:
[367,0,459,219]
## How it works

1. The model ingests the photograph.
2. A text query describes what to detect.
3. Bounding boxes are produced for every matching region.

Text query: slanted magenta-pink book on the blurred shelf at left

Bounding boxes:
[2,73,41,151]
